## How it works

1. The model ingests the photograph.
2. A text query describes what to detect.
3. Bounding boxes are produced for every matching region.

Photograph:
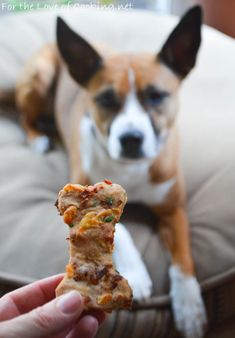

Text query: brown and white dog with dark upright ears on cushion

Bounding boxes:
[17,6,206,338]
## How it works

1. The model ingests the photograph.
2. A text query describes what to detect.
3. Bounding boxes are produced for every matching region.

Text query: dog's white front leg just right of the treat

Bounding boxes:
[113,223,152,300]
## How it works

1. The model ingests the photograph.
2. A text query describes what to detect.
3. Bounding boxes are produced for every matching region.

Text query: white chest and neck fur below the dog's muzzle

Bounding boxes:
[80,117,175,205]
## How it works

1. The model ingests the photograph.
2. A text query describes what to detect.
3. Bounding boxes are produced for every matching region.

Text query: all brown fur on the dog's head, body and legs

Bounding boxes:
[17,46,194,275]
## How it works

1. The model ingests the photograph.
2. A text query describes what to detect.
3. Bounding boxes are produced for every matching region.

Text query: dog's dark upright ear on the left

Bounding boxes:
[56,17,102,86]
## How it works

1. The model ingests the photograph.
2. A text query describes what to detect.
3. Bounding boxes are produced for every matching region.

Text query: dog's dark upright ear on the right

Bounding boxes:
[158,6,202,78]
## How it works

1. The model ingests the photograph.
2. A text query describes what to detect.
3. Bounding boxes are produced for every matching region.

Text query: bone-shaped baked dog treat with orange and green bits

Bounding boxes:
[56,180,132,312]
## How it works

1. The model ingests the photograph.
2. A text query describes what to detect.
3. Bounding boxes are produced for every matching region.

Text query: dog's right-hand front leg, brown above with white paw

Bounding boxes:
[158,207,206,338]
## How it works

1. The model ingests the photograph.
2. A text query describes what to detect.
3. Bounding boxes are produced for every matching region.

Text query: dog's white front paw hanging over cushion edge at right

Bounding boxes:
[169,265,207,338]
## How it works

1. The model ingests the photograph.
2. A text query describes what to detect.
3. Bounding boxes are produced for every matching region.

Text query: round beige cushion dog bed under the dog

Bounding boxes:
[0,9,235,338]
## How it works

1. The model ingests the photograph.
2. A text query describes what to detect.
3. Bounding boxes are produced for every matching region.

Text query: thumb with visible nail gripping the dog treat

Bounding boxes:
[0,291,83,338]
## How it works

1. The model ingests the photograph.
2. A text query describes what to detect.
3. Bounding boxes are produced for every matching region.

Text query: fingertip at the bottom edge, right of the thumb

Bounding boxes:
[66,315,99,338]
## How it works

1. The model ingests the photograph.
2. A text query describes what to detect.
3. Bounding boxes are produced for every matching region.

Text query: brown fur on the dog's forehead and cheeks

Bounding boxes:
[87,53,180,137]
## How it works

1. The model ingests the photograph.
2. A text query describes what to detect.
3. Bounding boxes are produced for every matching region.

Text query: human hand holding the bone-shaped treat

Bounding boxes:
[0,275,105,338]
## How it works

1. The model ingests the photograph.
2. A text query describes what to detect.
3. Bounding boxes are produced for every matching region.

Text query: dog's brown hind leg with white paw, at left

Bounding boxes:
[16,45,58,153]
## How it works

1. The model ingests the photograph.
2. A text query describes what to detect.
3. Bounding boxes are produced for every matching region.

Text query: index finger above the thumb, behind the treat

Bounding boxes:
[0,274,64,321]
